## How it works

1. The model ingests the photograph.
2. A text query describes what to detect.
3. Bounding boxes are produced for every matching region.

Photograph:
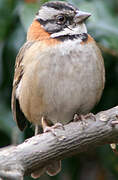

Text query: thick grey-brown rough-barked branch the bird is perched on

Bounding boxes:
[0,106,118,180]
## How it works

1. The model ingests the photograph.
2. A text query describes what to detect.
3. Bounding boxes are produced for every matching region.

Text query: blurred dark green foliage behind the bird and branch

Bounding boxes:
[0,0,118,180]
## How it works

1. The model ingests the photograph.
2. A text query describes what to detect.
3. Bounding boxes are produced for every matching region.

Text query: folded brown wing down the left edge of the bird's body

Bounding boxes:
[12,42,34,131]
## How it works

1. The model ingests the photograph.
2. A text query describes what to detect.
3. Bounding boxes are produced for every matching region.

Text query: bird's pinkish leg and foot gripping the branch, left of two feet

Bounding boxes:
[41,117,64,136]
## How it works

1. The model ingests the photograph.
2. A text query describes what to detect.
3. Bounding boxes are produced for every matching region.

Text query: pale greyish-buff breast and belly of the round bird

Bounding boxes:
[20,40,104,124]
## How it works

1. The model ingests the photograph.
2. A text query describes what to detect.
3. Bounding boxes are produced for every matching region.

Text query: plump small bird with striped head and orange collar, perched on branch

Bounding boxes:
[12,1,105,178]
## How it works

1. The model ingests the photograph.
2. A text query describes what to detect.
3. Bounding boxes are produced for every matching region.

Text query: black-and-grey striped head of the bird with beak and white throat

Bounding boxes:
[28,1,91,39]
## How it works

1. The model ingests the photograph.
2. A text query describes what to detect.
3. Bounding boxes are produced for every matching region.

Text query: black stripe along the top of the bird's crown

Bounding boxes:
[43,2,75,11]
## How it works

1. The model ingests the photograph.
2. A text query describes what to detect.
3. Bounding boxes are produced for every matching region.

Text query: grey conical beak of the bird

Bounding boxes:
[75,11,91,23]
